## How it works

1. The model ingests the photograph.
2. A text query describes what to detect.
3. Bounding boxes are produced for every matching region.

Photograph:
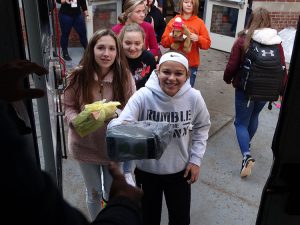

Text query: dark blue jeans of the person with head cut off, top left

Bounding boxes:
[59,13,88,49]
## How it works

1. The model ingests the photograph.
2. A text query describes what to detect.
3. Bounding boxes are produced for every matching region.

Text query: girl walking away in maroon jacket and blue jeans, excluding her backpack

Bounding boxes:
[223,8,287,177]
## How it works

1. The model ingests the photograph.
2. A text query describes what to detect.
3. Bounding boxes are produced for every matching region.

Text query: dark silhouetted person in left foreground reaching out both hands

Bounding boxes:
[0,60,143,225]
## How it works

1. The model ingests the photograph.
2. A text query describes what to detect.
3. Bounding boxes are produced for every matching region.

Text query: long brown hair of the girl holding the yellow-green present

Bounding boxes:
[67,29,132,108]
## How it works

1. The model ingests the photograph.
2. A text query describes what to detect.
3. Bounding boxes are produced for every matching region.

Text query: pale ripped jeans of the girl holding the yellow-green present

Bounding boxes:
[79,162,112,221]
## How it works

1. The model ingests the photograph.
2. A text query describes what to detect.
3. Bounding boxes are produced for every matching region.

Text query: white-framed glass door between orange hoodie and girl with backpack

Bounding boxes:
[205,0,248,52]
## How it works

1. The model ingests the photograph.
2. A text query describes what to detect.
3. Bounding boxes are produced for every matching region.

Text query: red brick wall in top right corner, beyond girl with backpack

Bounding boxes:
[252,0,300,31]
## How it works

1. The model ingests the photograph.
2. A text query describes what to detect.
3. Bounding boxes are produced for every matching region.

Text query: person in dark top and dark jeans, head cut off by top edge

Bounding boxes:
[56,0,90,61]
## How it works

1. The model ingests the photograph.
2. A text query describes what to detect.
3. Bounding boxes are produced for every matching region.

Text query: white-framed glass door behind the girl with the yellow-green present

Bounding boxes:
[86,0,122,39]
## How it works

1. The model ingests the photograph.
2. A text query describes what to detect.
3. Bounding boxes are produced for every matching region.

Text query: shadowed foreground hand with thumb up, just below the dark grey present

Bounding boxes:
[108,162,143,205]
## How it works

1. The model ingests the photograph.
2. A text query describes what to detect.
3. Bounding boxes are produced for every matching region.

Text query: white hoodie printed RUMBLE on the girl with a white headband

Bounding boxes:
[108,70,211,174]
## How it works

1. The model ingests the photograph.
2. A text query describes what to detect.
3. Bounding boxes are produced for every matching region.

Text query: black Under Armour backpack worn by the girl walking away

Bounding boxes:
[239,40,285,102]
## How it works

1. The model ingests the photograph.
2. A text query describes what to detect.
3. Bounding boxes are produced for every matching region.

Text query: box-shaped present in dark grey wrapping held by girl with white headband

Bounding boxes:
[106,120,172,162]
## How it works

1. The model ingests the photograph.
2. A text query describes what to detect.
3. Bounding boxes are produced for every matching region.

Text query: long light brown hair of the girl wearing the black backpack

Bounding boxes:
[240,7,272,53]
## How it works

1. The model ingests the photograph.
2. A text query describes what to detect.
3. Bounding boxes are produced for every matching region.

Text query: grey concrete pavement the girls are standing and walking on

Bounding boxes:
[63,49,279,225]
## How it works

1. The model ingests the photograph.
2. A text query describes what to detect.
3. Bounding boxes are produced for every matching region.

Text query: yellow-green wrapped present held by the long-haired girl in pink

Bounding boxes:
[72,99,121,137]
